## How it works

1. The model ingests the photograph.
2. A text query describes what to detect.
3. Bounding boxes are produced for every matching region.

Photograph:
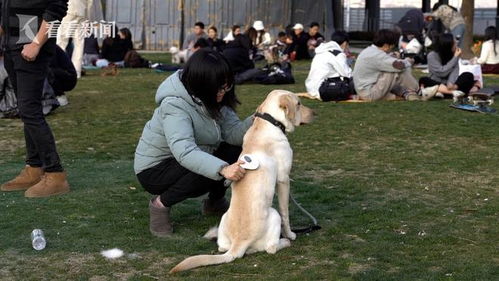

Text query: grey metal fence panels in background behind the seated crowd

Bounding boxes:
[105,0,496,50]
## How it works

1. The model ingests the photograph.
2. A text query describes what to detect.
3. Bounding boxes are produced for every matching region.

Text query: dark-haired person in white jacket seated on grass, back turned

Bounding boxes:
[305,31,355,100]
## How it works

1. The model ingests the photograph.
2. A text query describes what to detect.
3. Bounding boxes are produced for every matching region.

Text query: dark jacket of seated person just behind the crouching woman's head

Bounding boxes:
[222,34,255,73]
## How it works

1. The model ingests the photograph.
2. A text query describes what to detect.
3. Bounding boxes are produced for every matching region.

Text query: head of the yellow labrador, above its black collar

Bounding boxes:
[257,90,314,133]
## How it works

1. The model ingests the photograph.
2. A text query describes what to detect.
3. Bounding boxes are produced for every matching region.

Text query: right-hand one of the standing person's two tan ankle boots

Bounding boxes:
[24,172,69,197]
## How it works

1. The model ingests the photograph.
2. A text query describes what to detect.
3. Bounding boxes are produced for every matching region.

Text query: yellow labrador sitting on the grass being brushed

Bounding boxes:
[170,90,314,273]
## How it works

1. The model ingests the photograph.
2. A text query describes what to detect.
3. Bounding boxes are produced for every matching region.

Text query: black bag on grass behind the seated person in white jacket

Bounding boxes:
[319,77,354,101]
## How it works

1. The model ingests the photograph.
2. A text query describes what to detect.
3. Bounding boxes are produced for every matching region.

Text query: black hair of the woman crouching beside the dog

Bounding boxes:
[181,48,240,119]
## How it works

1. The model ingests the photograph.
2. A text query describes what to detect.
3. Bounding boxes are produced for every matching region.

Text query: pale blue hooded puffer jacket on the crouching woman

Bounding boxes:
[134,71,253,180]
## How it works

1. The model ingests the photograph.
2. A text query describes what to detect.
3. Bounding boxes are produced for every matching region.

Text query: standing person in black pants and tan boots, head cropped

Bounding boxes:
[0,0,69,197]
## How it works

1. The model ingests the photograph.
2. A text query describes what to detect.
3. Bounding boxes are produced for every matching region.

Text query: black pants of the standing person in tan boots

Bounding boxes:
[5,39,63,172]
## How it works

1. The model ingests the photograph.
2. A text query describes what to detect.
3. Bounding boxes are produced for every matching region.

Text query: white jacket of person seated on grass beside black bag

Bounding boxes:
[305,41,352,97]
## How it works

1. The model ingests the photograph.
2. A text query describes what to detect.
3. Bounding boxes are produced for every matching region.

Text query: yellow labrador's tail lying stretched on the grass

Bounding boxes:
[170,240,249,273]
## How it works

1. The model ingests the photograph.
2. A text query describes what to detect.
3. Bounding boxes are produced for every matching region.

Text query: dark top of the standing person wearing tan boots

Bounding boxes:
[0,0,68,49]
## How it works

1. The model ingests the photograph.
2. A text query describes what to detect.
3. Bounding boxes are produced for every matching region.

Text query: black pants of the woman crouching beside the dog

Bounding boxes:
[137,143,242,207]
